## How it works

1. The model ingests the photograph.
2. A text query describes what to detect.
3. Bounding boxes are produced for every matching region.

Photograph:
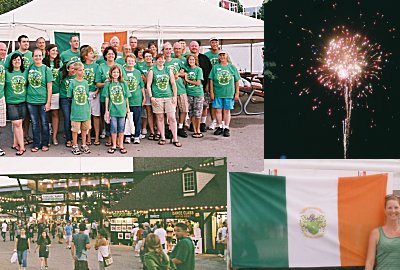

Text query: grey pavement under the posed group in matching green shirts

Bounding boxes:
[0,96,264,171]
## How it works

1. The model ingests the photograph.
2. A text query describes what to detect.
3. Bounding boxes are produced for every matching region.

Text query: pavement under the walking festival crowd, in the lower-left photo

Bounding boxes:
[0,237,226,270]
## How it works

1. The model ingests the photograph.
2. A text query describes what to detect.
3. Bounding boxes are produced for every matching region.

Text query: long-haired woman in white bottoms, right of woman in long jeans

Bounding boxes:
[43,44,61,145]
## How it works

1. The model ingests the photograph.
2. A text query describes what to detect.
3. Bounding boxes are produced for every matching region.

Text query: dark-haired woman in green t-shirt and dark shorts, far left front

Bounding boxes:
[4,53,27,156]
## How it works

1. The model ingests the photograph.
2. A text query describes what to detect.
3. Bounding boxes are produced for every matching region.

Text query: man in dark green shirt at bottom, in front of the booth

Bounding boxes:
[170,222,194,270]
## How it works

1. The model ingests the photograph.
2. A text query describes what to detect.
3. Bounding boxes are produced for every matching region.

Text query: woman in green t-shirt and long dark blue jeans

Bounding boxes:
[26,49,53,152]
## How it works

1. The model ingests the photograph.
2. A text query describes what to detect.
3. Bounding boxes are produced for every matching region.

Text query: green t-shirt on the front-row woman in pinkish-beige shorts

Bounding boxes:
[151,66,173,98]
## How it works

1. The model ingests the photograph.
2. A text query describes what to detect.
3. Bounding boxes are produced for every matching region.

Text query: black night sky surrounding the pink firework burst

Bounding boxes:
[264,0,400,159]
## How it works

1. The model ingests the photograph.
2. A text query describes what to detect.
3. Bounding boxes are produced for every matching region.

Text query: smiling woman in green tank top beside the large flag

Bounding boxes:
[365,195,400,270]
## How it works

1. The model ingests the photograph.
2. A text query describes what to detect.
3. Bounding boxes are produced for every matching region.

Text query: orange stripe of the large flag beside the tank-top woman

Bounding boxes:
[338,174,387,266]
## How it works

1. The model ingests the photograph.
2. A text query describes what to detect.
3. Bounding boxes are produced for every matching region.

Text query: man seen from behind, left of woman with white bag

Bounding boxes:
[71,223,90,270]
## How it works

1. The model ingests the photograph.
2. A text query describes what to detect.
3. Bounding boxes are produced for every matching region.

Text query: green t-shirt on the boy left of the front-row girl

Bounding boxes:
[67,79,90,122]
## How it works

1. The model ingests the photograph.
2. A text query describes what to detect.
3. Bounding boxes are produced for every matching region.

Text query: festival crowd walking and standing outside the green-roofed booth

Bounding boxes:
[1,219,228,270]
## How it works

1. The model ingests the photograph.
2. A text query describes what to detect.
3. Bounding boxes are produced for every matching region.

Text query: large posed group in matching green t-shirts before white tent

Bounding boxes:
[0,35,240,156]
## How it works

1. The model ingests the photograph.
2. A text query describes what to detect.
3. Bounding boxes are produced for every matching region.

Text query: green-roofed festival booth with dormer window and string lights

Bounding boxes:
[108,158,227,253]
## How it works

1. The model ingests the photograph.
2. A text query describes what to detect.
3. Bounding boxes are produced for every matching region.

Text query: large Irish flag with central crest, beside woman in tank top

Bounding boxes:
[228,173,387,268]
